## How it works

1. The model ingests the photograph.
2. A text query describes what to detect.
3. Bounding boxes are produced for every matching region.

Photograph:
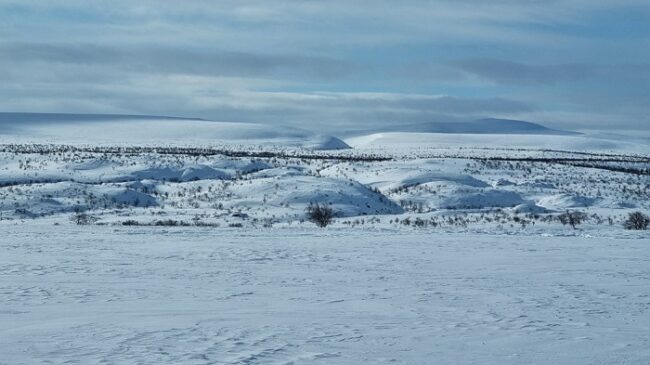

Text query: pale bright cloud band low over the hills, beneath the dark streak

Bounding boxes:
[0,65,535,132]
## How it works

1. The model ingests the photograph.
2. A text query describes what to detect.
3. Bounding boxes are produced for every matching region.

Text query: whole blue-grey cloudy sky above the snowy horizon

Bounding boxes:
[0,0,650,132]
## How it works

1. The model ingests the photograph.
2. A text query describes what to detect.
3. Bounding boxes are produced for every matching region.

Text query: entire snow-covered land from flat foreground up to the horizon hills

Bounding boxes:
[0,114,650,365]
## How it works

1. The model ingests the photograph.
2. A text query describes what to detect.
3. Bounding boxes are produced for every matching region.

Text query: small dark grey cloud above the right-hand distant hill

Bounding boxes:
[451,59,594,85]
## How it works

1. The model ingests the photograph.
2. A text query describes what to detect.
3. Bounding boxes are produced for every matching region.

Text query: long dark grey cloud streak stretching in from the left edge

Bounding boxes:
[0,43,355,80]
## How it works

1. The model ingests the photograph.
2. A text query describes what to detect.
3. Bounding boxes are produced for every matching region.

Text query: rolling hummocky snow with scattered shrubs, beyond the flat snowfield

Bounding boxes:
[0,141,650,226]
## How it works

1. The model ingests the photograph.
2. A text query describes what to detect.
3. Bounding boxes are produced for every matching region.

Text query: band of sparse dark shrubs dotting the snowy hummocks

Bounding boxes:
[0,144,650,230]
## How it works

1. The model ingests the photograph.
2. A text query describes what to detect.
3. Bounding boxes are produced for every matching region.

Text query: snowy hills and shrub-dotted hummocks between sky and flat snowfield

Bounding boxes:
[0,113,650,230]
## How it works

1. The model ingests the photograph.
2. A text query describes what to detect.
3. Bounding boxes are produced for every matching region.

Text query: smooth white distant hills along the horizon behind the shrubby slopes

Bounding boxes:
[0,113,650,153]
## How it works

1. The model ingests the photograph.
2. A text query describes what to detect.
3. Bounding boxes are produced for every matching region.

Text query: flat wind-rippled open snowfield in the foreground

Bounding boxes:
[0,220,650,365]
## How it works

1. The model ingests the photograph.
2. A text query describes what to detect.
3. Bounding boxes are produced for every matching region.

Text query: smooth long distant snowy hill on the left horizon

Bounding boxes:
[0,113,349,150]
